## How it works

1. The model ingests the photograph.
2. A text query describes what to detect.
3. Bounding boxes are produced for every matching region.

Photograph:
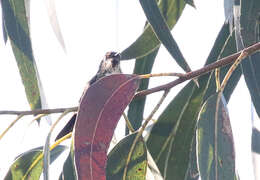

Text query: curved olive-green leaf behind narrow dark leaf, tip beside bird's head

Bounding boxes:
[121,0,186,60]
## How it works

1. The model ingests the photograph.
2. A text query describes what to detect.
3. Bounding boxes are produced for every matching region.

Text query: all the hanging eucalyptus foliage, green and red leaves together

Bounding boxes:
[0,0,260,180]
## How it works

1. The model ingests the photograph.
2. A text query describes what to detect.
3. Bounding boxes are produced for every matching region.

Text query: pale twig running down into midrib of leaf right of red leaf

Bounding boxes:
[123,89,169,180]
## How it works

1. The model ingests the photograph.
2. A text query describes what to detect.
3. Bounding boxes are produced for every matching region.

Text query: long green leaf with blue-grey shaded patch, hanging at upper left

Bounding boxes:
[1,0,41,109]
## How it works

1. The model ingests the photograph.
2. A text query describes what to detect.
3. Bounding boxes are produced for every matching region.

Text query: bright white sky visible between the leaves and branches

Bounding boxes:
[0,0,254,180]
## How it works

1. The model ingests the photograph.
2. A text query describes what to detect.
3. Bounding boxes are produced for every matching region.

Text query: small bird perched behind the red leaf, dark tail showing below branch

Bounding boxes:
[55,51,122,141]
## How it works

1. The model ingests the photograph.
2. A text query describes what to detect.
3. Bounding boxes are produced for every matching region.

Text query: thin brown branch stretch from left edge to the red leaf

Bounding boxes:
[0,107,78,115]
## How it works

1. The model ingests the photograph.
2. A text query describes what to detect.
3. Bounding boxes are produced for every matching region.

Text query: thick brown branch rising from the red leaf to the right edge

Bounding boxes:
[135,42,260,98]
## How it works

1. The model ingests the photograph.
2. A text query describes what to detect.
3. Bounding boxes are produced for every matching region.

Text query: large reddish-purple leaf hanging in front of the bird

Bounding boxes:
[74,74,139,180]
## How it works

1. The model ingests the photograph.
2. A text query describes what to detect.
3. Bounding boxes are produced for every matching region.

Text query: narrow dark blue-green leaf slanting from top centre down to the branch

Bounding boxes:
[139,0,191,72]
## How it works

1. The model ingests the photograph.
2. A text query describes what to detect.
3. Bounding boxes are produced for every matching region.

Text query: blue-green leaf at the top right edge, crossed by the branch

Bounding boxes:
[235,0,260,117]
